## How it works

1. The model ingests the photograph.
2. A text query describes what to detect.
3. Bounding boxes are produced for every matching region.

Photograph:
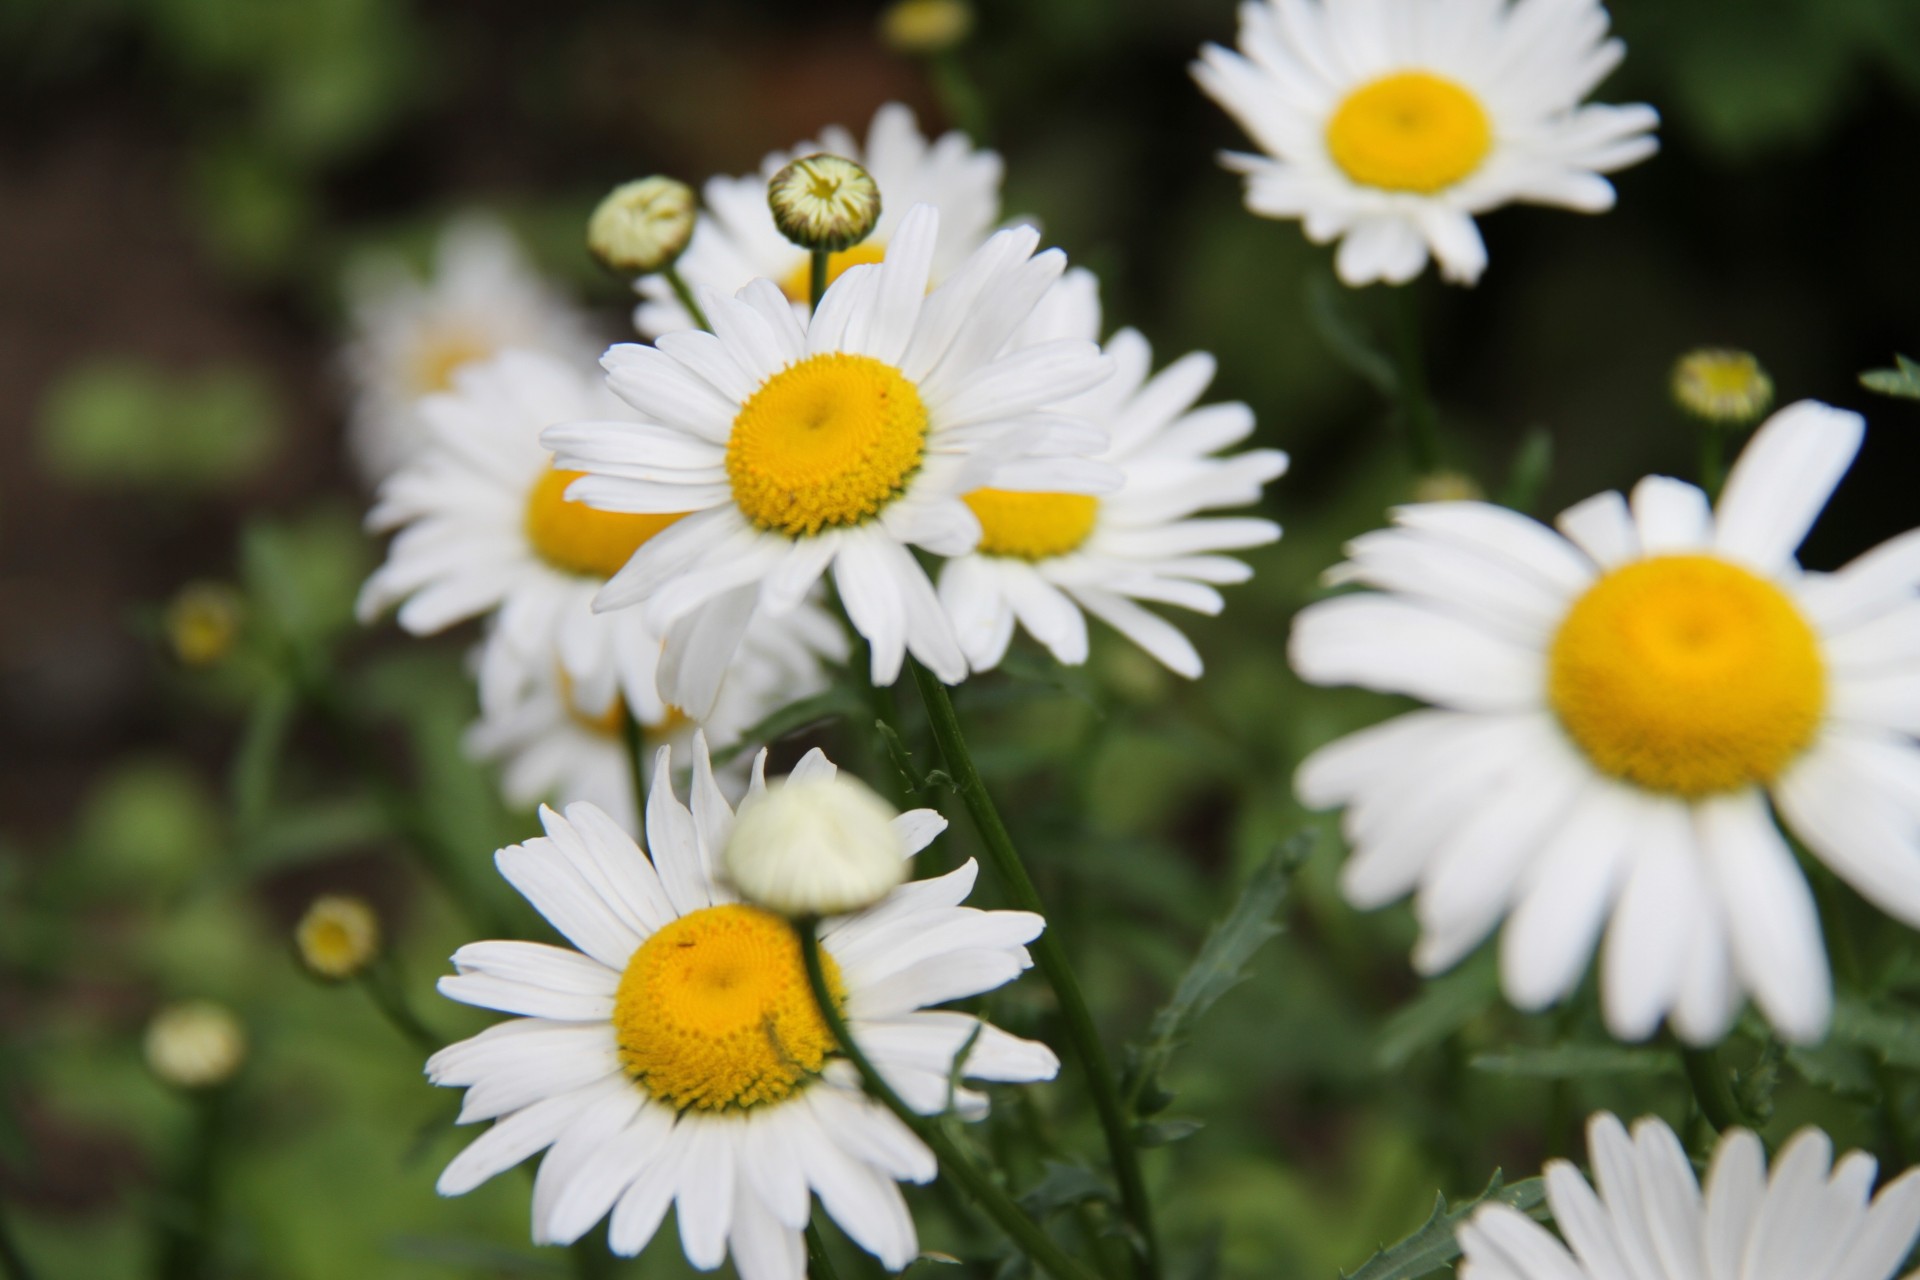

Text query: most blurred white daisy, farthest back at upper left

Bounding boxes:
[346,215,607,486]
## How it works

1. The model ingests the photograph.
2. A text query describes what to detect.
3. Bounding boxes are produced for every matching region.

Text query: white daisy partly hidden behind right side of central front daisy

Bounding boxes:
[939,269,1286,677]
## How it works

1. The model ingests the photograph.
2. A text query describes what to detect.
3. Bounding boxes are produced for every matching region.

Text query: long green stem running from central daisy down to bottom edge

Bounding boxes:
[908,658,1160,1280]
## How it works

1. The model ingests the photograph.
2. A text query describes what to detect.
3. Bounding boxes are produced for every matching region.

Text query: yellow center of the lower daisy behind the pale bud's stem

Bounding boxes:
[612,904,847,1111]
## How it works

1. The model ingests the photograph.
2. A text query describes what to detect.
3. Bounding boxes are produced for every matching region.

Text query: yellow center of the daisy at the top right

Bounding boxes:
[1327,71,1494,196]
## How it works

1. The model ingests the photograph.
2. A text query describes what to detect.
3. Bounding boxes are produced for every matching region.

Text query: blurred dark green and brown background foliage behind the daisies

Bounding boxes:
[0,0,1920,1280]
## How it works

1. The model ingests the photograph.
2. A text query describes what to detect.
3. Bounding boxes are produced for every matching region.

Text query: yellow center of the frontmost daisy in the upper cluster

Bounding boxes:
[726,351,927,537]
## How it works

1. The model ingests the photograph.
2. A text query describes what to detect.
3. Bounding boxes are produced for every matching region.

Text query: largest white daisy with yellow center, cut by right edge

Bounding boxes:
[1292,401,1920,1044]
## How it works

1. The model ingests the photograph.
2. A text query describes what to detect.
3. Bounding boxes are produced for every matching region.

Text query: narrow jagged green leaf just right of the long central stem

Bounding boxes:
[1127,831,1313,1115]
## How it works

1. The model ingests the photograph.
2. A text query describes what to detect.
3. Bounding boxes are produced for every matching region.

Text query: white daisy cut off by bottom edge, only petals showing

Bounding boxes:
[1455,1113,1920,1280]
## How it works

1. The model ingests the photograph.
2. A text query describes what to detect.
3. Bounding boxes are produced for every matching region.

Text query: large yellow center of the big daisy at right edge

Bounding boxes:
[1548,555,1826,796]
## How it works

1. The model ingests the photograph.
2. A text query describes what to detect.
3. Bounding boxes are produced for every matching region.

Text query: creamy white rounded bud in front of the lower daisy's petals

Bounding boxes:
[720,773,906,915]
